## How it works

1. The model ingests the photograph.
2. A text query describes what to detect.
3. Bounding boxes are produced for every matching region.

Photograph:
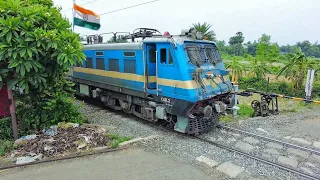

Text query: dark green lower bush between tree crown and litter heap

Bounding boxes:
[17,79,87,134]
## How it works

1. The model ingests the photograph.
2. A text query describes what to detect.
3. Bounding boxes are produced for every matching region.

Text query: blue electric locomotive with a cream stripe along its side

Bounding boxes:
[71,28,232,134]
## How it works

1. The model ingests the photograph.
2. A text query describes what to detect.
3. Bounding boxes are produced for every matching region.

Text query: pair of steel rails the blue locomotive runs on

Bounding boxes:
[75,99,320,180]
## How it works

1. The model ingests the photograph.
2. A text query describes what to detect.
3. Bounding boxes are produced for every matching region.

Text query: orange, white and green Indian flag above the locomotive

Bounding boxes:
[73,4,100,30]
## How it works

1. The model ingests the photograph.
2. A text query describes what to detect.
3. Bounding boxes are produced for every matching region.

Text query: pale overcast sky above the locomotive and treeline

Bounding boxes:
[53,0,320,45]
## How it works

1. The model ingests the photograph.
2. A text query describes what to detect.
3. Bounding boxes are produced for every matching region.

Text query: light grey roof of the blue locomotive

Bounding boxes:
[83,36,213,50]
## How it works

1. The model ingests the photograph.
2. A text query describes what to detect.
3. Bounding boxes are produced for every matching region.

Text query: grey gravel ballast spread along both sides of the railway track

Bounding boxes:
[78,101,320,180]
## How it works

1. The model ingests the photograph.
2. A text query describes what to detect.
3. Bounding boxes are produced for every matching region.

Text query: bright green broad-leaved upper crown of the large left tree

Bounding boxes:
[0,0,84,93]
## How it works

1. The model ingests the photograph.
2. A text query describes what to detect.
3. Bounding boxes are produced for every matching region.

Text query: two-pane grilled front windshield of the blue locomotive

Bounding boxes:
[185,44,222,66]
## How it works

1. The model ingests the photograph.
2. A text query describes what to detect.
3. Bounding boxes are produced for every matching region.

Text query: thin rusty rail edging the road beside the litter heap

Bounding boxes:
[0,146,128,171]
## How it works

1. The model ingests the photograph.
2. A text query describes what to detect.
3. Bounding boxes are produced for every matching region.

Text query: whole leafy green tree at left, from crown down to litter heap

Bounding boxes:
[0,0,85,133]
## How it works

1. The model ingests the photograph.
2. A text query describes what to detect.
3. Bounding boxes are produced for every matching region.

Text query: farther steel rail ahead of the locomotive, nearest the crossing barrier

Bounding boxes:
[218,125,320,155]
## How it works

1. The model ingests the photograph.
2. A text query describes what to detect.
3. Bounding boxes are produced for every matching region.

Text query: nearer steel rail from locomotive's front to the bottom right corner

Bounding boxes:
[191,136,320,180]
